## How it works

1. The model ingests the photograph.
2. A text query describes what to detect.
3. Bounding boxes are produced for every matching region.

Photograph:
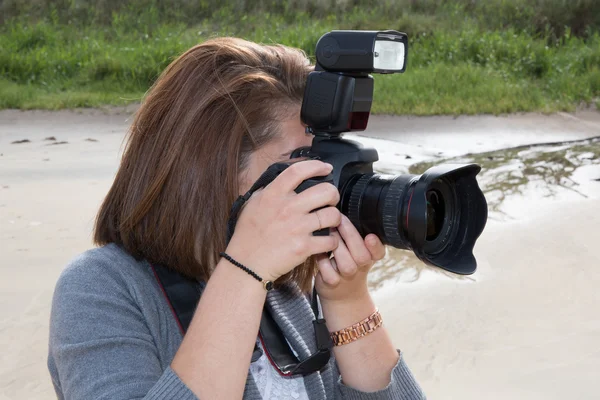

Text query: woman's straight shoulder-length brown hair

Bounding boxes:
[94,38,314,290]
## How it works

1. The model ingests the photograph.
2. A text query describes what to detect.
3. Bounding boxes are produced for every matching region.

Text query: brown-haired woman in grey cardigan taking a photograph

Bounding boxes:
[48,38,424,400]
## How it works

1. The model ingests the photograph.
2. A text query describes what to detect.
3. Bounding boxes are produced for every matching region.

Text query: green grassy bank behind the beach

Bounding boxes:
[0,0,600,115]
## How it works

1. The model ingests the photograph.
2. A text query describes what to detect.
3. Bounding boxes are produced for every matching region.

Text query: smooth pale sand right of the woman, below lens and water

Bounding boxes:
[377,199,600,399]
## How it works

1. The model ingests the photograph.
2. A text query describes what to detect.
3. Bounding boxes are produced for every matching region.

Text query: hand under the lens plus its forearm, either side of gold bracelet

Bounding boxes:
[316,217,399,392]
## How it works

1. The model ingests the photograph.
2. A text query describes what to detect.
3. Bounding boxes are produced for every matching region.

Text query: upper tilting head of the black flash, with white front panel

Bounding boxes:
[315,30,408,74]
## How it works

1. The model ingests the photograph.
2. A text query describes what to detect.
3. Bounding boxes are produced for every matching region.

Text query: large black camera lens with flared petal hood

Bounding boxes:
[340,164,487,274]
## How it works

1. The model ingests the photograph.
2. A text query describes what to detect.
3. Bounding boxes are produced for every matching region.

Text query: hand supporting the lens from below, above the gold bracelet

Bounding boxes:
[315,215,385,302]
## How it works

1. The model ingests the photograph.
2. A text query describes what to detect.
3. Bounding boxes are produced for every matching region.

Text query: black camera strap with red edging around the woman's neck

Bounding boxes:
[151,164,333,376]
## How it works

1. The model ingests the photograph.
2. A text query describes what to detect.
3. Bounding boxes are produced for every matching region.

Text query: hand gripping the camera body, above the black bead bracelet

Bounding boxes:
[226,160,341,281]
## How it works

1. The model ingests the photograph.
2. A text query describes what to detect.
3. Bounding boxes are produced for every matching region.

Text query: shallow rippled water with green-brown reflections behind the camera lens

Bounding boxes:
[369,137,600,290]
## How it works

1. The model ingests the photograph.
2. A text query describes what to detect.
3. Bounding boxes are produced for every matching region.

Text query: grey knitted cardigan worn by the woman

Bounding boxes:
[48,245,425,400]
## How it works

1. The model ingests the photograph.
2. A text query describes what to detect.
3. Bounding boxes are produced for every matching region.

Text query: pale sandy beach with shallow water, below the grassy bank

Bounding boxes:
[0,110,600,400]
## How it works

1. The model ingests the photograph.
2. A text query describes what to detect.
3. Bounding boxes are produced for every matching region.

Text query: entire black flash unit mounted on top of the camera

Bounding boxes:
[300,30,408,137]
